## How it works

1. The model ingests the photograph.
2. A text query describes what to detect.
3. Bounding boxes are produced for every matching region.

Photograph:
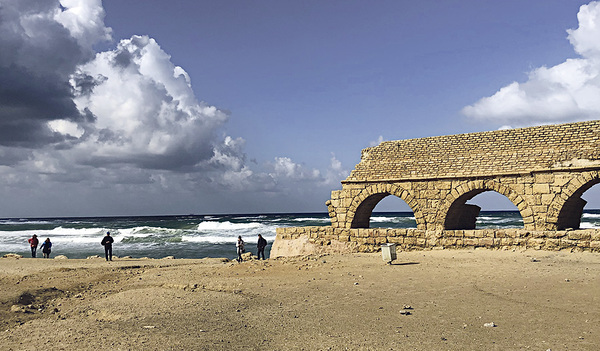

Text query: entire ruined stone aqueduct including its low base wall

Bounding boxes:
[271,121,600,257]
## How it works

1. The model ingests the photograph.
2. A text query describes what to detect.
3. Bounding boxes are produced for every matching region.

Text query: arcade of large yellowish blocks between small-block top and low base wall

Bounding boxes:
[327,169,600,230]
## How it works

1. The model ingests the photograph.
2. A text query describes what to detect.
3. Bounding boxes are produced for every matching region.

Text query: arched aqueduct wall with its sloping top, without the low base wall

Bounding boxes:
[327,121,600,234]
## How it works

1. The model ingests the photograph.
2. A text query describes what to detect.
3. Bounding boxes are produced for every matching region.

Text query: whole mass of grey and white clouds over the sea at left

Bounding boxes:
[0,0,347,214]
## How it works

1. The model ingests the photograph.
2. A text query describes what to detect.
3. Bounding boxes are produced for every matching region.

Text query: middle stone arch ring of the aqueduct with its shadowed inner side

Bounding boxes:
[434,180,535,230]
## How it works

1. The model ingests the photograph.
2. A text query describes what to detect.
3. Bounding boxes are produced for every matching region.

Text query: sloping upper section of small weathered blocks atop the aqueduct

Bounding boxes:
[346,121,600,182]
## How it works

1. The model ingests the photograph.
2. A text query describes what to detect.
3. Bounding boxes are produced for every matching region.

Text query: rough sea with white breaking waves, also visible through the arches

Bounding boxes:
[0,210,600,259]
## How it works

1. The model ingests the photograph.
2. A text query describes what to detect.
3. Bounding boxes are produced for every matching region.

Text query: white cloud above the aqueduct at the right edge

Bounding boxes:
[462,1,600,127]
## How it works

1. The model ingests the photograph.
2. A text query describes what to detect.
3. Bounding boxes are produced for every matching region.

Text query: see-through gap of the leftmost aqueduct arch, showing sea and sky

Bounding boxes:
[369,195,417,228]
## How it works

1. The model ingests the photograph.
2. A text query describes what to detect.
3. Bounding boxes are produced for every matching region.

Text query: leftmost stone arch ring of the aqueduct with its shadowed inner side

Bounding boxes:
[346,184,426,229]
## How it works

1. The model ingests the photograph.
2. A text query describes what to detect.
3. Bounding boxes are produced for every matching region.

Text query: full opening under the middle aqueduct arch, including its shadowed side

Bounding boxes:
[444,189,523,230]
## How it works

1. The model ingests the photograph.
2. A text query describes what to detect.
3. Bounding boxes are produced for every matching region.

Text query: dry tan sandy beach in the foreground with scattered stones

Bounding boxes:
[0,250,600,351]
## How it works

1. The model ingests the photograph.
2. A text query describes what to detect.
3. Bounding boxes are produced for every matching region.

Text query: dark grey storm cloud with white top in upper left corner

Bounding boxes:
[0,0,110,147]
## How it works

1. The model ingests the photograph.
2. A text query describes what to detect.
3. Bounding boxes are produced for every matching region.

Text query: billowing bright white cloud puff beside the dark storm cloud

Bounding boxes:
[72,36,228,169]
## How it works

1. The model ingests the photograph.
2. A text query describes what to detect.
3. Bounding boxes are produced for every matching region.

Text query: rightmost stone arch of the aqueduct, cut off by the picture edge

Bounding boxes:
[546,171,600,230]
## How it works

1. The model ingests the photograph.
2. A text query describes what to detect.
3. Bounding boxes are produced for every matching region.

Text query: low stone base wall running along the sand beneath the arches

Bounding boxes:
[271,227,600,257]
